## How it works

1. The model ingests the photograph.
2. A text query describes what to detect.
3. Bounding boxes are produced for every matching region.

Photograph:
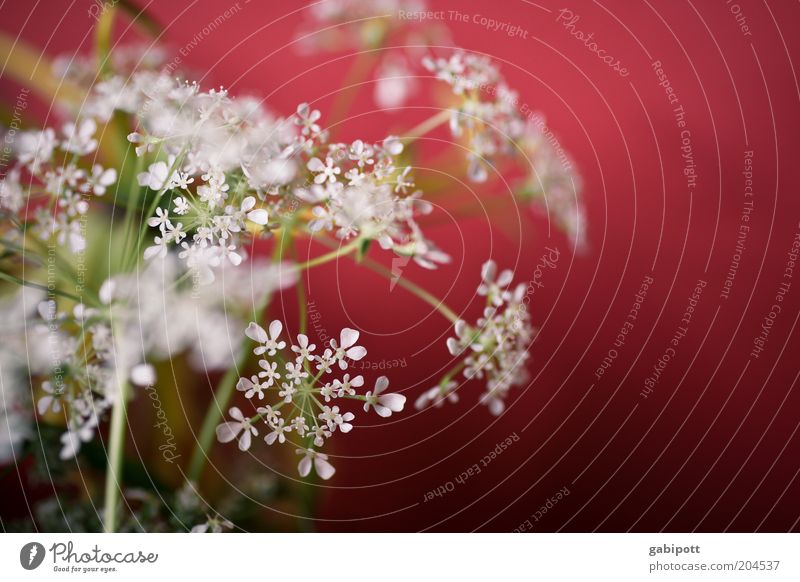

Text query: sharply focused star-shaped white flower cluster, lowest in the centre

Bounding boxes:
[217,320,406,479]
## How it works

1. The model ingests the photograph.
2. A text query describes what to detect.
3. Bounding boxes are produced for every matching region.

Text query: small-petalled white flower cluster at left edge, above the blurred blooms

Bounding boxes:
[0,118,117,253]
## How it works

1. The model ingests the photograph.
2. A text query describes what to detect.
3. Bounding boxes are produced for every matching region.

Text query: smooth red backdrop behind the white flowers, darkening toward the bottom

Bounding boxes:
[0,0,800,531]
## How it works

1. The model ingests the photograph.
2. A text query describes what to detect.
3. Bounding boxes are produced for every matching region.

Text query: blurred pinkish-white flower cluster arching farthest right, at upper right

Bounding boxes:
[423,51,586,248]
